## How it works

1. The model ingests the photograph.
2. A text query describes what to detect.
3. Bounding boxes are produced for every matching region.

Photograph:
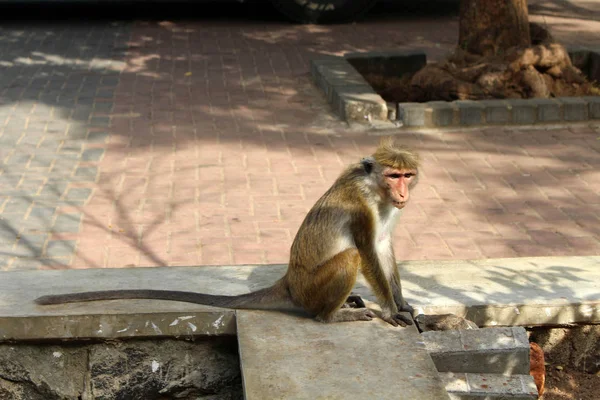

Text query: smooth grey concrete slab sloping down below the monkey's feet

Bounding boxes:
[237,311,449,400]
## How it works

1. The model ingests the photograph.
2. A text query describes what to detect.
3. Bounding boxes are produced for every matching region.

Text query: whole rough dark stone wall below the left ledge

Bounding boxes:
[0,338,243,400]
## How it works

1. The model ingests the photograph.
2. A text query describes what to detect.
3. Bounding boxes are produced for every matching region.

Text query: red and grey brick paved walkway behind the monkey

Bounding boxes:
[0,2,600,270]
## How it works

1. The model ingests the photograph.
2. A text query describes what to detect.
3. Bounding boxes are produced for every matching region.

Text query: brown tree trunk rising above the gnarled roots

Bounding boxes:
[458,0,531,56]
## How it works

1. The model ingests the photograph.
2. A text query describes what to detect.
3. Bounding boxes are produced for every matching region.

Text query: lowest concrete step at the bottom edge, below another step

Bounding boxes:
[440,372,538,400]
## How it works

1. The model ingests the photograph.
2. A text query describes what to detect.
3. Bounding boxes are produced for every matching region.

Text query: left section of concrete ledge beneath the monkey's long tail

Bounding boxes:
[0,267,251,340]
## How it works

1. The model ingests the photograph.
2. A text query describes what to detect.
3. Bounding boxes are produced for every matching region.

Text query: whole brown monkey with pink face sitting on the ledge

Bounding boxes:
[35,137,420,327]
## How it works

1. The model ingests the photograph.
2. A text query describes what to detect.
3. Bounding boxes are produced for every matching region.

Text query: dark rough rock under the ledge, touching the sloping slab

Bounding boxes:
[90,338,243,400]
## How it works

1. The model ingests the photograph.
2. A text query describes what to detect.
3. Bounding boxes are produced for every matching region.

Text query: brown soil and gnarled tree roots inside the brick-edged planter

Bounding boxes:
[359,24,600,103]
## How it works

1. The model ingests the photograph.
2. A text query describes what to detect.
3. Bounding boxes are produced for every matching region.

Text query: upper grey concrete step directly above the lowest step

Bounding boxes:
[422,327,529,375]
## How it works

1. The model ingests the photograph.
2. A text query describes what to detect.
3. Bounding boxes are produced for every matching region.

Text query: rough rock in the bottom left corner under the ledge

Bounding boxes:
[0,344,87,400]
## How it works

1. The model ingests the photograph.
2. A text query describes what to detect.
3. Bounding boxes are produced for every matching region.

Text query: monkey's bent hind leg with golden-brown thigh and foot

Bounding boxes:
[302,249,375,322]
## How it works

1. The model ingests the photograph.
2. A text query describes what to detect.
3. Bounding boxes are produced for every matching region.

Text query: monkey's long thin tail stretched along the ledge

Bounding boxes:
[34,280,297,310]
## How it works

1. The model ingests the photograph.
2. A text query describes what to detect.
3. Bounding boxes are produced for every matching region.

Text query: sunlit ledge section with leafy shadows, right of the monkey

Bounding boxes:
[370,256,600,327]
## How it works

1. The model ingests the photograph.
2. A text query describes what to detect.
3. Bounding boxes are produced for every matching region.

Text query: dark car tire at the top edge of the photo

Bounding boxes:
[271,0,377,24]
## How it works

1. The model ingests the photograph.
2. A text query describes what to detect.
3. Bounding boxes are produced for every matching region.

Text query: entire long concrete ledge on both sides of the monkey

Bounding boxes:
[0,256,600,340]
